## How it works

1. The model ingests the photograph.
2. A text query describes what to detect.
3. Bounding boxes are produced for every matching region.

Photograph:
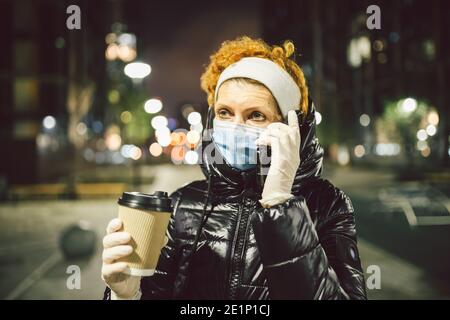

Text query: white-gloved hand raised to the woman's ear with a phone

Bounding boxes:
[256,110,301,208]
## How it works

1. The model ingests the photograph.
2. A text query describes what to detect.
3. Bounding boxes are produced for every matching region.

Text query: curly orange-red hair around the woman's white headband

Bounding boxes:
[200,36,308,115]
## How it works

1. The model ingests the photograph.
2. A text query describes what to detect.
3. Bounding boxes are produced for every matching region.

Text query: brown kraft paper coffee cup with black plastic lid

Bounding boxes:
[117,191,172,276]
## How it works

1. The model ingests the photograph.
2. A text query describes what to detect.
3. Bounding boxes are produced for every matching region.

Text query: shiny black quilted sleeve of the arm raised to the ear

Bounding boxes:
[252,193,366,299]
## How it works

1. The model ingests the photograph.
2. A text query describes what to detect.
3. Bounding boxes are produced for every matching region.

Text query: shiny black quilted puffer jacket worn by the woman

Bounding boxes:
[105,103,366,299]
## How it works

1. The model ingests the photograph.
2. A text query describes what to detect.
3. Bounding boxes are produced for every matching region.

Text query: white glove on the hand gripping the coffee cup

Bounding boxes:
[102,218,141,300]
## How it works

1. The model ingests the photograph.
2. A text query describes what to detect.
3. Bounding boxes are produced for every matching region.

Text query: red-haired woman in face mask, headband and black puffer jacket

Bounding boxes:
[102,37,366,299]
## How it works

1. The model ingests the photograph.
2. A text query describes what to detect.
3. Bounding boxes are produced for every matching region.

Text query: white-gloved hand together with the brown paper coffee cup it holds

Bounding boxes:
[102,191,172,298]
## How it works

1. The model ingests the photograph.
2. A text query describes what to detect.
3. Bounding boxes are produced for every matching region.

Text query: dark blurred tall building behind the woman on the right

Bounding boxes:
[263,0,450,164]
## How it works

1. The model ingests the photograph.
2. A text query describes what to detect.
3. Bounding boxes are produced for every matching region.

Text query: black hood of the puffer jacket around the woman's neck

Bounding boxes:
[200,100,323,196]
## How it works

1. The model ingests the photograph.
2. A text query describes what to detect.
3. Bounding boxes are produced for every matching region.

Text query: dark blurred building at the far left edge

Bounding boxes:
[0,1,66,183]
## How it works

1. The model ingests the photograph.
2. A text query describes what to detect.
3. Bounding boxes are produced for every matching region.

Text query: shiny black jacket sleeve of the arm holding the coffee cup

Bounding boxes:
[103,192,181,300]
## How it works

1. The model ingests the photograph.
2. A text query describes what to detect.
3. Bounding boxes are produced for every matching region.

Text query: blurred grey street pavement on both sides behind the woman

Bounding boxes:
[0,164,450,299]
